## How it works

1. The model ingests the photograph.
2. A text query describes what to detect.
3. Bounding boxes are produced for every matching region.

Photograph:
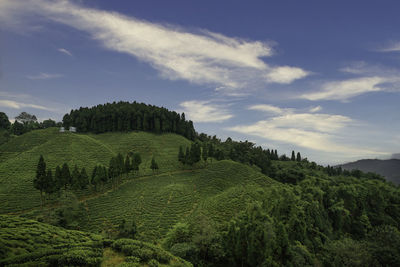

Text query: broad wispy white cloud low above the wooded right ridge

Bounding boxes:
[228,105,384,155]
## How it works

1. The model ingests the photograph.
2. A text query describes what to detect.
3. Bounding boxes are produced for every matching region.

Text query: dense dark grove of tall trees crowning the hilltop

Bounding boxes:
[63,102,196,140]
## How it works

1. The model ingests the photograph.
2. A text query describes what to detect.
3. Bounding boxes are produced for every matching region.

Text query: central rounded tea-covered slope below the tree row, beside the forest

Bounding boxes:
[77,161,275,241]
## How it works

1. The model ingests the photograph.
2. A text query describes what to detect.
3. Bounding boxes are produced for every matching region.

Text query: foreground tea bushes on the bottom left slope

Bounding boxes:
[0,215,191,266]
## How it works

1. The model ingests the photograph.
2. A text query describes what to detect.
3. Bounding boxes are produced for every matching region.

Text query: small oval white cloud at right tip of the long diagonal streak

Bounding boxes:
[266,66,310,84]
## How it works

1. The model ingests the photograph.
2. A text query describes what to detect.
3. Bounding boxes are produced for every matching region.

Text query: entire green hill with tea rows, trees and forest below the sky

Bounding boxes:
[0,105,400,266]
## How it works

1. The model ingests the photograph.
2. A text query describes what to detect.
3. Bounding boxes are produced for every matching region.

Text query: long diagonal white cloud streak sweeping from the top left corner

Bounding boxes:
[0,0,308,92]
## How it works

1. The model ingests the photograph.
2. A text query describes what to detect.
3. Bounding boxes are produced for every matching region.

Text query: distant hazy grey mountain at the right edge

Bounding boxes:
[340,160,400,184]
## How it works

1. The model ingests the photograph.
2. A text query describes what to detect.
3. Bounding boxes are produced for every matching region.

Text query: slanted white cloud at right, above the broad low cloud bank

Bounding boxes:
[300,76,384,101]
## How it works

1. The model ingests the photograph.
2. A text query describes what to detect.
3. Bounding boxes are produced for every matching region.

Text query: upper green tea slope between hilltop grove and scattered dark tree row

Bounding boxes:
[0,128,189,213]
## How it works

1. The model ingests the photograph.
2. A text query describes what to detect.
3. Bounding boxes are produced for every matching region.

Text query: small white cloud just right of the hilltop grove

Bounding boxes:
[180,100,233,122]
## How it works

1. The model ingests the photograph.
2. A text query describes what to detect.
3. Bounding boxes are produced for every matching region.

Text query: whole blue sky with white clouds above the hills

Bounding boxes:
[0,0,400,164]
